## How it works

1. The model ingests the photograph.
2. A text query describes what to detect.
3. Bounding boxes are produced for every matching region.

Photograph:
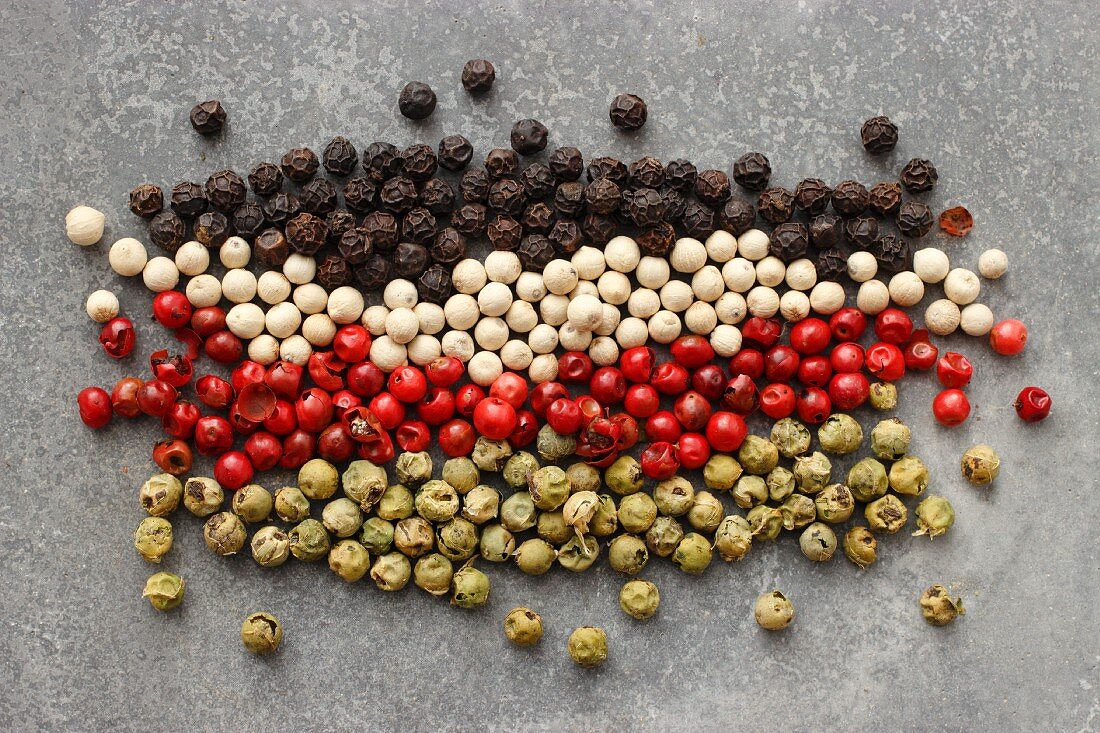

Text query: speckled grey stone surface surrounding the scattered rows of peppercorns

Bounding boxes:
[0,0,1100,731]
